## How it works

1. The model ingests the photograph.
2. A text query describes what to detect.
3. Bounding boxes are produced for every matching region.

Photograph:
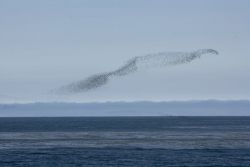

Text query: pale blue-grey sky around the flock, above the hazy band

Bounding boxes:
[0,0,250,103]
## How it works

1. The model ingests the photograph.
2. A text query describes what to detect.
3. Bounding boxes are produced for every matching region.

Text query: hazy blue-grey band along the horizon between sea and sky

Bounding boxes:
[0,100,250,117]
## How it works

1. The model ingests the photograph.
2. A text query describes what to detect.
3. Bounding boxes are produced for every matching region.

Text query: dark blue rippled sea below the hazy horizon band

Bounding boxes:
[0,116,250,167]
